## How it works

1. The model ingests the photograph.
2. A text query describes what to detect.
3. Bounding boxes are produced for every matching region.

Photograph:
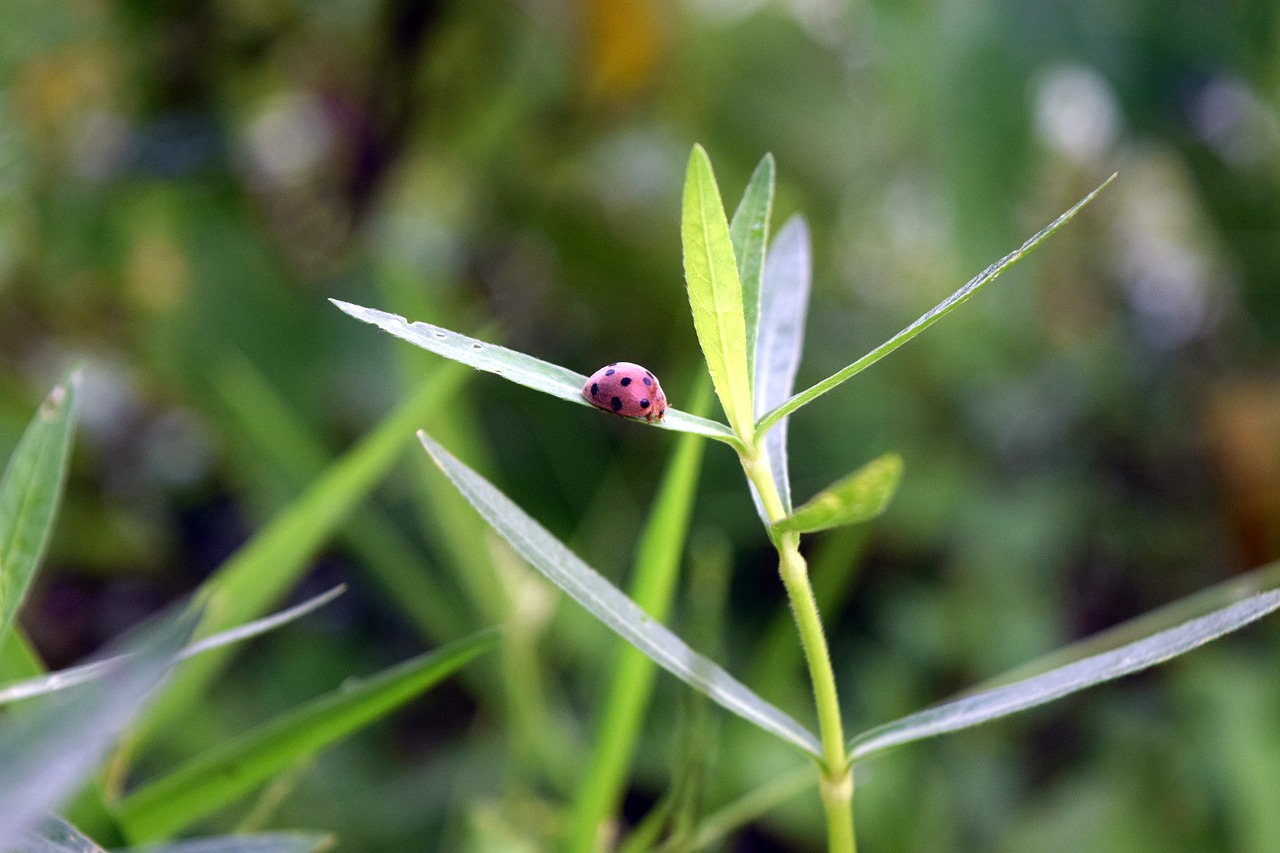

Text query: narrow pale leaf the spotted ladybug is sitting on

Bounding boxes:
[329,300,737,443]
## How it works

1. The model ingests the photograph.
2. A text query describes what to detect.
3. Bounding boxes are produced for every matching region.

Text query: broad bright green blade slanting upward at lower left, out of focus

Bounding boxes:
[119,630,497,841]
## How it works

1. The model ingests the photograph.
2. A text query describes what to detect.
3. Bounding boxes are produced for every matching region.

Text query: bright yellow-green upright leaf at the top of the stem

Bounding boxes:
[680,145,754,442]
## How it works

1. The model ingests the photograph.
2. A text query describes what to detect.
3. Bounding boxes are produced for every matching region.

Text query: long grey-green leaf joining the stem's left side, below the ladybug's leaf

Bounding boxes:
[419,432,820,756]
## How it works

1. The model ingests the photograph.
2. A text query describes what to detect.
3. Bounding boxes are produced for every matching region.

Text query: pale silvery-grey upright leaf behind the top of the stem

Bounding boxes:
[751,215,813,524]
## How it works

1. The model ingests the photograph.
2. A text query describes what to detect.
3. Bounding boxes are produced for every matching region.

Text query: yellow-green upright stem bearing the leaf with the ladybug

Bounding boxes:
[741,447,856,853]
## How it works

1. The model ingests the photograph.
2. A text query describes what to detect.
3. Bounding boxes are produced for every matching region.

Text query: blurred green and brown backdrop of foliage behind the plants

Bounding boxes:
[0,0,1280,853]
